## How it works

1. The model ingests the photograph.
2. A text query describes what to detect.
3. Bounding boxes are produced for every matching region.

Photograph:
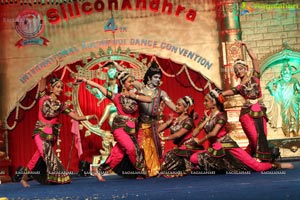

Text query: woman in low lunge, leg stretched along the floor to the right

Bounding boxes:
[190,90,293,173]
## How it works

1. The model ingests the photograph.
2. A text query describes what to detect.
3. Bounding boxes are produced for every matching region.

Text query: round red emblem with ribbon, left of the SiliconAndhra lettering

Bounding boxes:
[15,10,49,48]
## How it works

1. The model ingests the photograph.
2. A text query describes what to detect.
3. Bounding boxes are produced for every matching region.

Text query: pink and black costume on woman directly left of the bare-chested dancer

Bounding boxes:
[99,94,145,177]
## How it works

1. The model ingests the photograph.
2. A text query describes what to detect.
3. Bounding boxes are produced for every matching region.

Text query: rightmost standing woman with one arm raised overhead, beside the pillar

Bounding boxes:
[222,41,272,161]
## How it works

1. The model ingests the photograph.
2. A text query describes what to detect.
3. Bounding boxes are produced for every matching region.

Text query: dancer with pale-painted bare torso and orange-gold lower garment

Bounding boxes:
[114,61,176,177]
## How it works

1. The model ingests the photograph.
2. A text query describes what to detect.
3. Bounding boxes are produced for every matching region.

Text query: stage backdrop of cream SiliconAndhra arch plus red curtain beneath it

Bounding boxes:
[0,0,221,173]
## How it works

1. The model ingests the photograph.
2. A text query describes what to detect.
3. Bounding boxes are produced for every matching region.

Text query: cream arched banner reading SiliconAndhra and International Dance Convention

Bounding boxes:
[0,0,221,119]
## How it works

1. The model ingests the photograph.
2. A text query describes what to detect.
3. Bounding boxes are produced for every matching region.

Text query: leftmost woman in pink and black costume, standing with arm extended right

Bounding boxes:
[21,78,97,187]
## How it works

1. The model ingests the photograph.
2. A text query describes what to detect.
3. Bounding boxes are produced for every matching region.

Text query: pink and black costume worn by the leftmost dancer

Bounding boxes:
[27,96,71,184]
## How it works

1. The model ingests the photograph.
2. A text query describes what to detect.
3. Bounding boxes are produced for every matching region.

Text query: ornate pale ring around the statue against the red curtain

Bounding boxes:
[72,49,148,162]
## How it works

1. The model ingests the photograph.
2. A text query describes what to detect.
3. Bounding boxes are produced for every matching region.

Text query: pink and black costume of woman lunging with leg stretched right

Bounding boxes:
[190,112,272,173]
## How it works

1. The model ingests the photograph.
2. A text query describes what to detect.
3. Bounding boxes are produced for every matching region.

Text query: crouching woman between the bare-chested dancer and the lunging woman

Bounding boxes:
[158,96,201,178]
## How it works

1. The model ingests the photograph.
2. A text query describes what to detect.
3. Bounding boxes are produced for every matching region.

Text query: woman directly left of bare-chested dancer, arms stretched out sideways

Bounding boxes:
[77,71,152,181]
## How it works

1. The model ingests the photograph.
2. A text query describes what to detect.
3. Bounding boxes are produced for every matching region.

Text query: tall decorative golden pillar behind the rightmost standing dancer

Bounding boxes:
[216,0,248,146]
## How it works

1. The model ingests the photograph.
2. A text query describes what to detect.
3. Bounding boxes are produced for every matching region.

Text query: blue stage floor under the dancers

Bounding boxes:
[0,161,300,200]
